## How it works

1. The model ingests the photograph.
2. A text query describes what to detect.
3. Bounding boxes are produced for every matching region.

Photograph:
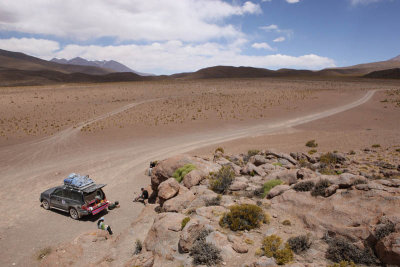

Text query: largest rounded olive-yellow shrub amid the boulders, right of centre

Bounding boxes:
[219,204,267,231]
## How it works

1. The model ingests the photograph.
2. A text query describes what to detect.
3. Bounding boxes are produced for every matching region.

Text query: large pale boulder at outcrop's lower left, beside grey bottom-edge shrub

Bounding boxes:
[144,212,186,260]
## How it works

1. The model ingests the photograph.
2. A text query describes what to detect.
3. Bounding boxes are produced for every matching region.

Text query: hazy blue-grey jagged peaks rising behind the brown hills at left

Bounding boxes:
[50,57,152,76]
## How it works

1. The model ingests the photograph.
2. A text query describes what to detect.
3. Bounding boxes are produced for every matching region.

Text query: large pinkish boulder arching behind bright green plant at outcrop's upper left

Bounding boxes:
[151,155,220,191]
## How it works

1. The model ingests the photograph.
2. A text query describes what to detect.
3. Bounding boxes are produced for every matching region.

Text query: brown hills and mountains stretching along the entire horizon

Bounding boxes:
[0,49,400,86]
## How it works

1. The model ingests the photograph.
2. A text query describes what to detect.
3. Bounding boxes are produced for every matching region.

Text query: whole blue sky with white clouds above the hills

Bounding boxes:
[0,0,400,74]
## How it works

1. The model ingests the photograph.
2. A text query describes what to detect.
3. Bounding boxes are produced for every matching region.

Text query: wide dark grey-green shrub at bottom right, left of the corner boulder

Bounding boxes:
[325,237,376,265]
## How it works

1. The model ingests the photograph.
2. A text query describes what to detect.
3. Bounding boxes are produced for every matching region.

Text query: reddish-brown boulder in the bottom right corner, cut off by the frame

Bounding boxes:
[376,233,400,266]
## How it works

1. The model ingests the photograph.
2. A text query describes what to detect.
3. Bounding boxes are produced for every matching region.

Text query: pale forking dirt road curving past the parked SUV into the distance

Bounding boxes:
[0,91,375,266]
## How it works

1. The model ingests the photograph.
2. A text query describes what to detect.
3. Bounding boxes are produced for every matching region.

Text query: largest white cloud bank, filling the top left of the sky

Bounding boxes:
[0,0,262,41]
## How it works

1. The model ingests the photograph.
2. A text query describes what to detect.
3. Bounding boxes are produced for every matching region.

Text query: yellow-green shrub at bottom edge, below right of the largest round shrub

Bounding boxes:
[261,235,293,265]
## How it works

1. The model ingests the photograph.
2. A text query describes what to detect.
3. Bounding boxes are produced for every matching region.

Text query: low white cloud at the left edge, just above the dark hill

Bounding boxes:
[0,38,60,59]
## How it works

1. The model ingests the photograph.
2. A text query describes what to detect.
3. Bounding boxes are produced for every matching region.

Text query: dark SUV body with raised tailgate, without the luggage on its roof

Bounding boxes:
[40,184,109,220]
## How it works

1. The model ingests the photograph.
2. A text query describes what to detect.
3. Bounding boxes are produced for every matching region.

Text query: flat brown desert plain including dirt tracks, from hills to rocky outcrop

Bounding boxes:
[0,78,400,266]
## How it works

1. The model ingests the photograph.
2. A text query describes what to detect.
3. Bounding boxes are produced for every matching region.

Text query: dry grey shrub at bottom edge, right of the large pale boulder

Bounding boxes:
[189,229,222,266]
